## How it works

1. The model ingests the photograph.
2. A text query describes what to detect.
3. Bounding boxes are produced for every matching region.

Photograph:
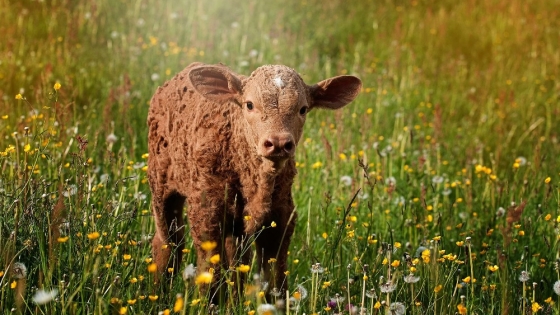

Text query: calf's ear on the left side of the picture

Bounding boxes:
[189,65,242,102]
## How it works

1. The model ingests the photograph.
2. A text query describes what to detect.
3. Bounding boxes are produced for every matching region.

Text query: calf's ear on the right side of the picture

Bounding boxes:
[309,75,362,109]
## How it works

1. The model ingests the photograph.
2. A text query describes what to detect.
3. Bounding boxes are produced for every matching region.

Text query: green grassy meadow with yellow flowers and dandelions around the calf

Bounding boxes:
[0,0,560,315]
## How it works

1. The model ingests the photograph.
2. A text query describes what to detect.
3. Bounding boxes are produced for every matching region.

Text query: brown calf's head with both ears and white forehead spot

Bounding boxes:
[189,65,362,168]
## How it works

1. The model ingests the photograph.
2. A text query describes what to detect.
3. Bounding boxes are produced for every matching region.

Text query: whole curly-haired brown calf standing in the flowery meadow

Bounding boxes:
[148,63,361,302]
